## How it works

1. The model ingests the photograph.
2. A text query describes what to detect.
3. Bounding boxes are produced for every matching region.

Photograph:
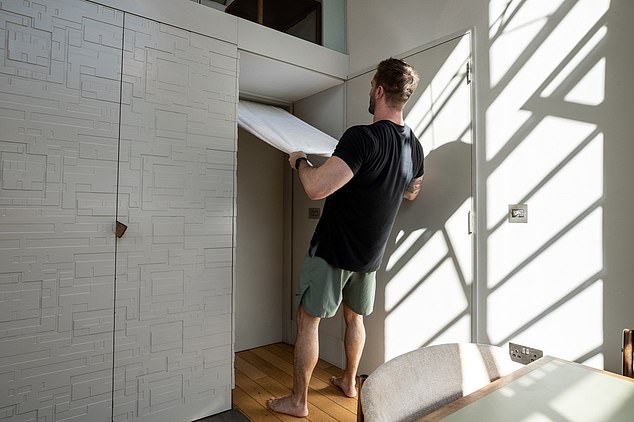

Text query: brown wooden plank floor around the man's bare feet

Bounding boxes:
[233,343,357,422]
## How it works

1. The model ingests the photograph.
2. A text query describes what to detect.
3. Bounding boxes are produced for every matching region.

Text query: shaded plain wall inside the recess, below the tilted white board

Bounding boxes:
[234,129,289,351]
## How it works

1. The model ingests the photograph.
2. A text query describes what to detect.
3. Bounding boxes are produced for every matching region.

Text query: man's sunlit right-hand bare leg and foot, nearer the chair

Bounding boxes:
[331,303,365,397]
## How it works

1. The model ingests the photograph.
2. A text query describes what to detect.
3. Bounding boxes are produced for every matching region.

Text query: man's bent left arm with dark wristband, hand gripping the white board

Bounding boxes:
[288,151,354,201]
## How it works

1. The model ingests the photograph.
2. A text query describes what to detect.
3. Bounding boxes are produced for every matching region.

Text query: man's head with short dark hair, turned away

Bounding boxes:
[374,57,418,107]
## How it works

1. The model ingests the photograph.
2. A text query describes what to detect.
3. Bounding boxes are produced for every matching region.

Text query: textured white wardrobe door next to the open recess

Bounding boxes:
[114,14,237,422]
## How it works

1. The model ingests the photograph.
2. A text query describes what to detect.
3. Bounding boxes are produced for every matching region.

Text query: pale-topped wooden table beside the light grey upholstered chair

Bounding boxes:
[419,356,634,422]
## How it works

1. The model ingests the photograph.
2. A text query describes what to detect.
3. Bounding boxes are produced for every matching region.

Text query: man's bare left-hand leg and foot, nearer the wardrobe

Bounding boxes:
[267,305,321,417]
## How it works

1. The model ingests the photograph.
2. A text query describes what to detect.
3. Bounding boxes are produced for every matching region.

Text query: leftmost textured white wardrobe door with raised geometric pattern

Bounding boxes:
[0,0,123,421]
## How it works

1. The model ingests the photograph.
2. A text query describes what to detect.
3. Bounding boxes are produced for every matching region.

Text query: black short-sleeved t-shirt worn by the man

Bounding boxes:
[311,120,423,272]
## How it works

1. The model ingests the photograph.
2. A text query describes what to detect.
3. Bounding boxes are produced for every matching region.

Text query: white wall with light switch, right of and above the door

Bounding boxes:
[348,0,634,371]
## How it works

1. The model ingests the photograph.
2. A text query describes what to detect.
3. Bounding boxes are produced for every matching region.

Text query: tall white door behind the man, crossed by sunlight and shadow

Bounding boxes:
[347,34,473,371]
